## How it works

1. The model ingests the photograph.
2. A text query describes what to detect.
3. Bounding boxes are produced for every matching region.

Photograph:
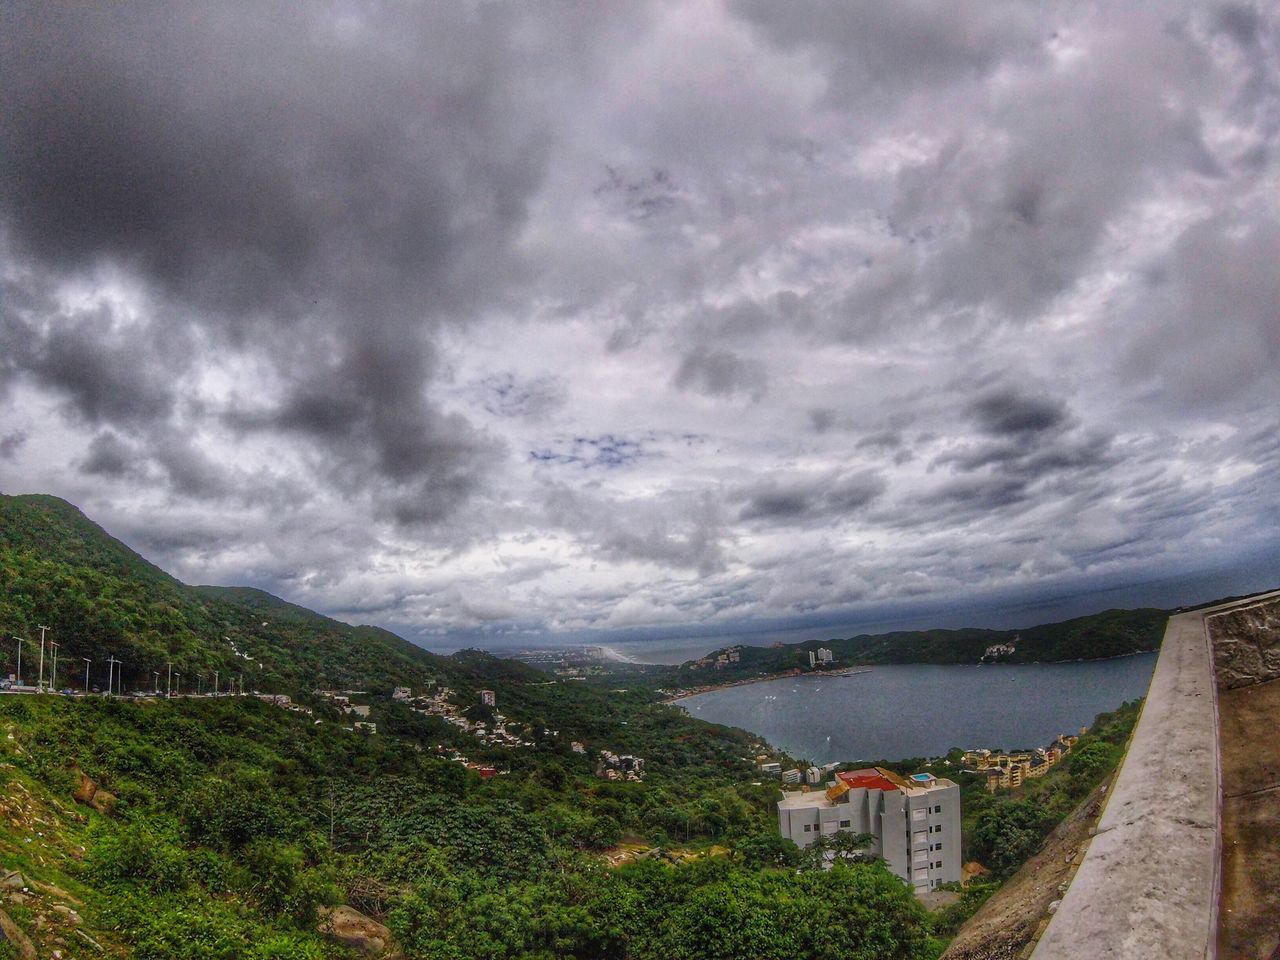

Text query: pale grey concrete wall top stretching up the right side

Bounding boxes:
[1032,594,1277,960]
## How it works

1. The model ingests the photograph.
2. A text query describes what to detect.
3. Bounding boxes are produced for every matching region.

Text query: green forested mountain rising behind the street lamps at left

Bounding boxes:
[0,495,509,692]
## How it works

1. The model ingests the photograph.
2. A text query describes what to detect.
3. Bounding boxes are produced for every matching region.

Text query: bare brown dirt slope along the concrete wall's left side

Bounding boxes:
[942,777,1111,960]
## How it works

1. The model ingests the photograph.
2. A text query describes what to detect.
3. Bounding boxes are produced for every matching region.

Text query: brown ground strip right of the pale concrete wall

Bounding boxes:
[1217,680,1280,960]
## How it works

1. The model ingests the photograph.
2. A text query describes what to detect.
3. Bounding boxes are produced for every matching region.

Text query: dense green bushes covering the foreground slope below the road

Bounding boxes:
[0,698,937,960]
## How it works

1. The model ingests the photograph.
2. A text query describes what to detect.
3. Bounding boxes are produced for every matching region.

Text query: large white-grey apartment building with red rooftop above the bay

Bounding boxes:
[778,767,961,893]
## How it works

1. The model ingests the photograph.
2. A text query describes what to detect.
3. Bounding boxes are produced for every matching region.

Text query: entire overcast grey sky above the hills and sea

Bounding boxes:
[0,0,1280,645]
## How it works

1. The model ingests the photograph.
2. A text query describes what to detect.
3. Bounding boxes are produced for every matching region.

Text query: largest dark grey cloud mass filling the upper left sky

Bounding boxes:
[0,4,544,527]
